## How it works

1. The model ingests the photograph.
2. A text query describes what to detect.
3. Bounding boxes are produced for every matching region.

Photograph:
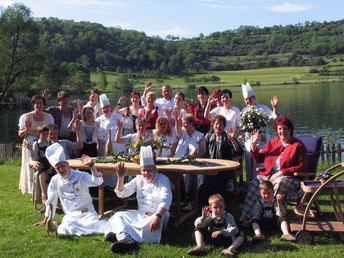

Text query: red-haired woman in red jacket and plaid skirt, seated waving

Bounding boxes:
[239,117,308,222]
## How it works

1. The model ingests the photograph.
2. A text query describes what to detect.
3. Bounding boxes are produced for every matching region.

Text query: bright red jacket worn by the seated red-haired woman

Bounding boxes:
[251,137,308,176]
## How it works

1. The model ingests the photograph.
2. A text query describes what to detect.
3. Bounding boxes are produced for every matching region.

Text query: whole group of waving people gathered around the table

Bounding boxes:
[19,82,307,256]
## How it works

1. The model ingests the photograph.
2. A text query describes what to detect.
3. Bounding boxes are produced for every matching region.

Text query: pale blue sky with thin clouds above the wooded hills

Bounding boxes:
[0,0,344,38]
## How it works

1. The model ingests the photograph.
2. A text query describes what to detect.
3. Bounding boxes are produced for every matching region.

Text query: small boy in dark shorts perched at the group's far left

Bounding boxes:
[24,125,56,211]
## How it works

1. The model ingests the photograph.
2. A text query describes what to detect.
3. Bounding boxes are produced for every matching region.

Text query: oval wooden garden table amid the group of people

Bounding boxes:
[68,158,240,225]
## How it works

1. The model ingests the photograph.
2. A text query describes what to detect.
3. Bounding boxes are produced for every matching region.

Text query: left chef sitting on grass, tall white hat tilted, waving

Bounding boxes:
[34,143,106,236]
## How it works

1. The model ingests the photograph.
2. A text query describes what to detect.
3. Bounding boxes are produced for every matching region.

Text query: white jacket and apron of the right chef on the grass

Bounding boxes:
[105,173,172,243]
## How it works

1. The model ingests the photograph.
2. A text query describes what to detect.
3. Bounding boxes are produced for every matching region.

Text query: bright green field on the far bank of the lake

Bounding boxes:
[91,60,344,91]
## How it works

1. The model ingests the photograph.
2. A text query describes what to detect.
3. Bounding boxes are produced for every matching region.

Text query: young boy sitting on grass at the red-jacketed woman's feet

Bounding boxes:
[251,180,296,241]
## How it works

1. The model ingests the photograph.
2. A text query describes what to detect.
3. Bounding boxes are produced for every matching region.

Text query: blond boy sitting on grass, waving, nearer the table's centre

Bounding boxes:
[188,194,244,257]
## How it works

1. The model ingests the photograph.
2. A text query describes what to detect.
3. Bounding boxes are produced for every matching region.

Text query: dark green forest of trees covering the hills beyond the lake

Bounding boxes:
[0,4,344,102]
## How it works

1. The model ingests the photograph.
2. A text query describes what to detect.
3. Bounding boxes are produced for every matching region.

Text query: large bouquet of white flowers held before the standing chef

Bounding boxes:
[240,106,269,133]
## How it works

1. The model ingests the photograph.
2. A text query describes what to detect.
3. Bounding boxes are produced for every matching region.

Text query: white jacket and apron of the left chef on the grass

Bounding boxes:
[45,169,106,236]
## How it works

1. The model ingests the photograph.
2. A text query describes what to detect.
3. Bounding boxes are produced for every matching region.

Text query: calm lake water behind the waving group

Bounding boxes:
[0,82,344,149]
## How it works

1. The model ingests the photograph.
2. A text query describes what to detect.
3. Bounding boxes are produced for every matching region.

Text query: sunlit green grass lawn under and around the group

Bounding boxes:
[0,159,344,257]
